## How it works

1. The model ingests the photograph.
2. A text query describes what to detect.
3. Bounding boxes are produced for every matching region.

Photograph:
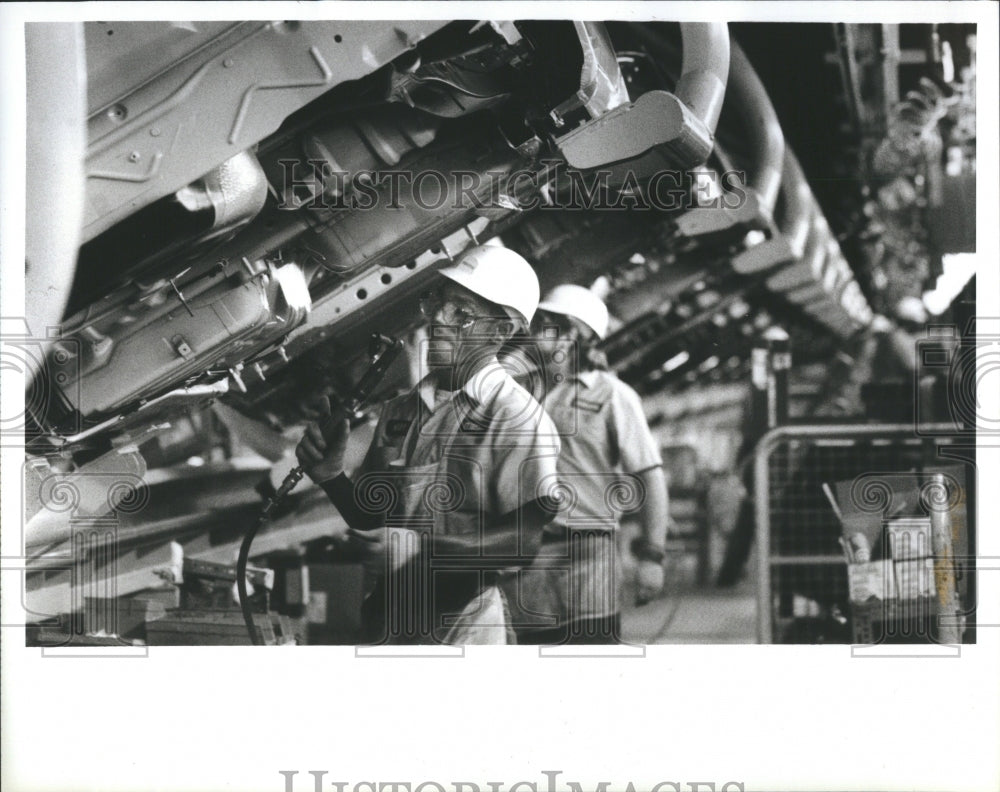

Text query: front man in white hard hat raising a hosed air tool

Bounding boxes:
[297,245,559,643]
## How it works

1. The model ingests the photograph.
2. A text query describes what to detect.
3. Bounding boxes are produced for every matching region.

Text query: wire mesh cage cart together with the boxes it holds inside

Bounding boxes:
[754,424,975,643]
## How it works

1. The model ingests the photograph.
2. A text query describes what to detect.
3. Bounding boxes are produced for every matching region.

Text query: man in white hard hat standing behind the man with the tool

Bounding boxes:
[504,284,667,644]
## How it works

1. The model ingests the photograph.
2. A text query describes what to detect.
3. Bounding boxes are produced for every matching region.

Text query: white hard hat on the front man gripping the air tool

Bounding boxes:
[438,245,539,328]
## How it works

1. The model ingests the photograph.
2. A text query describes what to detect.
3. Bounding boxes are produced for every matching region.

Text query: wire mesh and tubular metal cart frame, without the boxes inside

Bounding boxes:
[754,424,975,643]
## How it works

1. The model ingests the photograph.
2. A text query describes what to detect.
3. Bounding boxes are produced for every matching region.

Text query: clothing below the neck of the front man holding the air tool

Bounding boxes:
[354,360,559,643]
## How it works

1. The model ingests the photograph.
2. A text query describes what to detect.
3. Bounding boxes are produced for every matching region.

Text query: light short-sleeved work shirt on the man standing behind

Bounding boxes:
[545,371,663,529]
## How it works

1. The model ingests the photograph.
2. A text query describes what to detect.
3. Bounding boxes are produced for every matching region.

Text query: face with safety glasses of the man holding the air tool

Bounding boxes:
[420,281,511,369]
